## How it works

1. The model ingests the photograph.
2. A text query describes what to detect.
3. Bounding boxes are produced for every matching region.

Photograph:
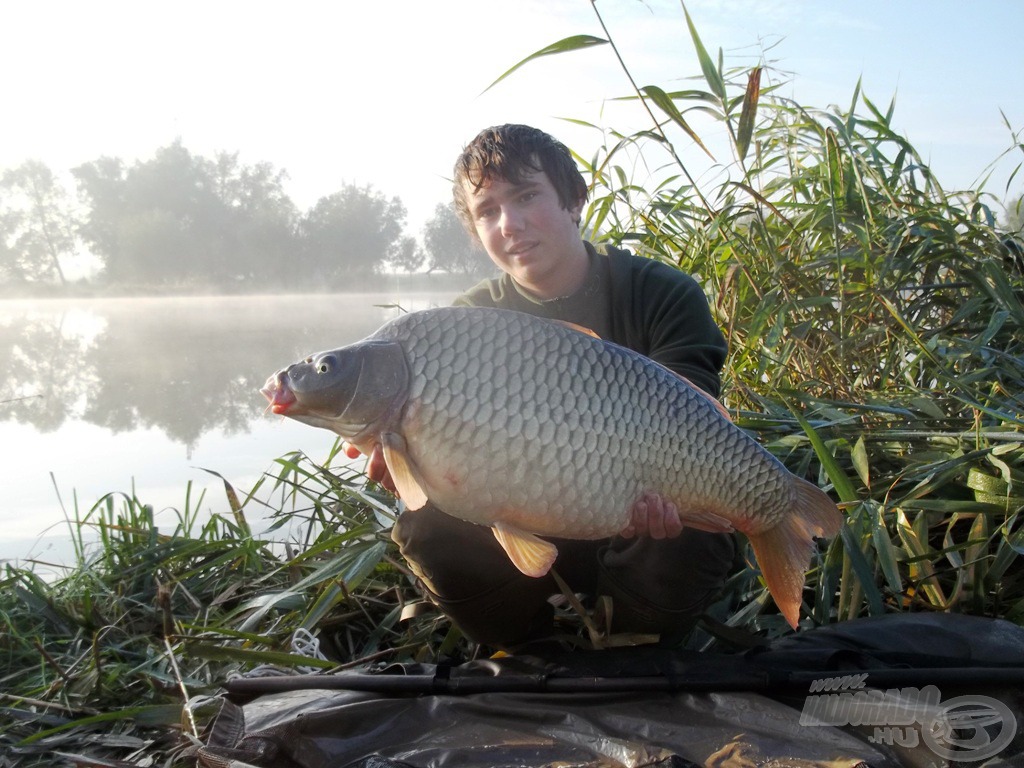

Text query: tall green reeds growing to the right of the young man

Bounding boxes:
[536,1,1024,630]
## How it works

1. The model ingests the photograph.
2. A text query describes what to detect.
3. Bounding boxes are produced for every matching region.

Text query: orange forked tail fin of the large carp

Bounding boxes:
[749,476,843,629]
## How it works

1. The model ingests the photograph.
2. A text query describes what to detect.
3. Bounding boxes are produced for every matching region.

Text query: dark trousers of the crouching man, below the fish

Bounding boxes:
[391,505,735,647]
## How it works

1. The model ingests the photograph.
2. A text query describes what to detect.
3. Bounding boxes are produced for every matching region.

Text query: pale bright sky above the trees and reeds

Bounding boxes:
[0,0,1024,234]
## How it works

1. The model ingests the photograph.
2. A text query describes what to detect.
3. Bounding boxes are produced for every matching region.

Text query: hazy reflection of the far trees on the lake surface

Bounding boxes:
[0,294,451,446]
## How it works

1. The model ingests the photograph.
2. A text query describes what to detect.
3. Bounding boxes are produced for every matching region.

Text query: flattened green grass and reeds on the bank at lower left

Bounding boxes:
[0,455,423,766]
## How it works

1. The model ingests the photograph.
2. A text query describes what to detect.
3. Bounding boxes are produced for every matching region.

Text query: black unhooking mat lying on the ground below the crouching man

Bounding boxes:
[192,614,1024,768]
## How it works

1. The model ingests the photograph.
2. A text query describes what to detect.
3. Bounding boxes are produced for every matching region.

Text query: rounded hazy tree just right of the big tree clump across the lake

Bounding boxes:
[299,184,406,288]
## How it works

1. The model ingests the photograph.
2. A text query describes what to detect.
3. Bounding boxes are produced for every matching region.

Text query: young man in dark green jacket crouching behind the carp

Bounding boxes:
[362,125,734,646]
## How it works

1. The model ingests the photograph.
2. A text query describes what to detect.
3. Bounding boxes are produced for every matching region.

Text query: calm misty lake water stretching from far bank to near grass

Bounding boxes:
[0,291,457,562]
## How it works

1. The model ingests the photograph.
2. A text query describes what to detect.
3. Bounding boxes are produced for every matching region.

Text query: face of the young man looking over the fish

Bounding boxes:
[466,171,586,298]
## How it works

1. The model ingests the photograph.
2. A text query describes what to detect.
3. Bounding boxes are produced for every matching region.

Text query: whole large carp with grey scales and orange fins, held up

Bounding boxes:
[261,307,842,627]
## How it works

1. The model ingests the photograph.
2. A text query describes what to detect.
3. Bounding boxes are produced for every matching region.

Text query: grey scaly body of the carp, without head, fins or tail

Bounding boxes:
[372,308,790,539]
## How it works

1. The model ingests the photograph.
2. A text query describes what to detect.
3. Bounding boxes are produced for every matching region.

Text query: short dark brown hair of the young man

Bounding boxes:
[453,123,587,237]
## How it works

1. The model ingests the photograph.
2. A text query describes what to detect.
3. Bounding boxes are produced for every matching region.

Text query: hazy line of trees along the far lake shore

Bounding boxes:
[0,141,490,293]
